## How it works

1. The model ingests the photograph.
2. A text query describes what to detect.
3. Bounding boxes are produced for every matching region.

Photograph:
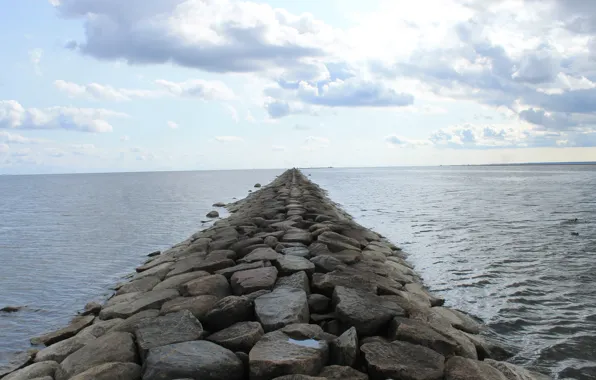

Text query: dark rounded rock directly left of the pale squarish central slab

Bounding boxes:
[205,296,254,332]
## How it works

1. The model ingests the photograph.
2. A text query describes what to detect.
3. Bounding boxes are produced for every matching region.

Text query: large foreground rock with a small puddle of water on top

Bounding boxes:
[248,331,329,380]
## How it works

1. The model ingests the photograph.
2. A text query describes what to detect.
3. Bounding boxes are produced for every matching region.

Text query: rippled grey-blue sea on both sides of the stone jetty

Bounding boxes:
[0,165,596,379]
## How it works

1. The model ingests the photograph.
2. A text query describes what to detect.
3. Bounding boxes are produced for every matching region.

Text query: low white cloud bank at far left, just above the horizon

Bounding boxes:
[0,100,128,133]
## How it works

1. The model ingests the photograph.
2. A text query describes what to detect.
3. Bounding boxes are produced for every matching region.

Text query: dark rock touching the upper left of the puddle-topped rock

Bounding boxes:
[207,322,264,352]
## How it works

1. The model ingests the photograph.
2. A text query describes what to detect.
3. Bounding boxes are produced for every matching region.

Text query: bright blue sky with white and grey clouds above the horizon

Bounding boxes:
[0,0,596,174]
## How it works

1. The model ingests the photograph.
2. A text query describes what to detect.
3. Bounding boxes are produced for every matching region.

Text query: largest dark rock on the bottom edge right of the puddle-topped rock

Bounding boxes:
[360,341,444,380]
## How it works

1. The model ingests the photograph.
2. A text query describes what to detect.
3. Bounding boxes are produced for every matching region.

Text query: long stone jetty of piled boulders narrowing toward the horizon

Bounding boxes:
[0,169,550,380]
